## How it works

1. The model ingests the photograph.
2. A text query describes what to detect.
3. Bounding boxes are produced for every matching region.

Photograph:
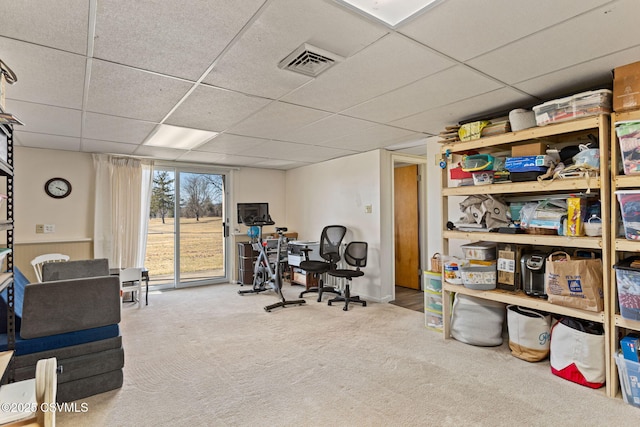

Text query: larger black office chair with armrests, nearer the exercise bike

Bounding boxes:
[300,225,347,302]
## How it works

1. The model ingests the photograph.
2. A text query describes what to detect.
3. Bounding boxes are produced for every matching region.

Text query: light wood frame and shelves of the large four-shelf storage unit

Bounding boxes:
[441,115,619,395]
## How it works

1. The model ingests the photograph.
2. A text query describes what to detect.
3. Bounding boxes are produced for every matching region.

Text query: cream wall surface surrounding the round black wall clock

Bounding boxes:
[14,147,95,243]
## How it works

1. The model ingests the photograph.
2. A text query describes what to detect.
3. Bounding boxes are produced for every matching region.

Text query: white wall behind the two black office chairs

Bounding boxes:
[285,151,384,301]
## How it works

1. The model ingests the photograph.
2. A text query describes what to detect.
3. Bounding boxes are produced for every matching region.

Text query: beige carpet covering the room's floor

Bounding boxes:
[58,285,640,426]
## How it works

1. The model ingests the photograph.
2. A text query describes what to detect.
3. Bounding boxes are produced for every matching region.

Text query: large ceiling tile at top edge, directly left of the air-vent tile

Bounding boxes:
[95,0,264,81]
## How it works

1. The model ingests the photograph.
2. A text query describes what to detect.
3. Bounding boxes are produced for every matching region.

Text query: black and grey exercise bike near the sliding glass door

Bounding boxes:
[238,216,306,312]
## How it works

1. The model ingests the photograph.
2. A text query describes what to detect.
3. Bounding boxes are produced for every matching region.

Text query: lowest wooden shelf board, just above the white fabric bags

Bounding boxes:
[442,282,604,323]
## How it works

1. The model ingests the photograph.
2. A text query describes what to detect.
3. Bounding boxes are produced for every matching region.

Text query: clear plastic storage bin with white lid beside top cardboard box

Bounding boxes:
[533,89,613,126]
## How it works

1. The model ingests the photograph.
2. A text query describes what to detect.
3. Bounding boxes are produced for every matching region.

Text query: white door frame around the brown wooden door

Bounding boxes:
[391,153,428,301]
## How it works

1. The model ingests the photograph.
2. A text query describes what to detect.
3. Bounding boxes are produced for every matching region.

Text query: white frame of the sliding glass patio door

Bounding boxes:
[151,161,235,289]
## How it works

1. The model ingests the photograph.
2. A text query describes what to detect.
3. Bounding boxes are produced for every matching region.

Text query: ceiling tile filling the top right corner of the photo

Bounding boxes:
[468,0,640,84]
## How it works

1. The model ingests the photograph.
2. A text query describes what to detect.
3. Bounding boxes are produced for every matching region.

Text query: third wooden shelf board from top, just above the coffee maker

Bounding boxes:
[442,230,602,249]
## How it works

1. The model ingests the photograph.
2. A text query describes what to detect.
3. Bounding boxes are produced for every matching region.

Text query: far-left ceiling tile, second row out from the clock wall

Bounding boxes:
[7,99,82,137]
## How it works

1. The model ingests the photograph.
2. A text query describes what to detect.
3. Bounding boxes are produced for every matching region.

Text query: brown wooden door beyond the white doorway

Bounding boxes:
[393,165,420,289]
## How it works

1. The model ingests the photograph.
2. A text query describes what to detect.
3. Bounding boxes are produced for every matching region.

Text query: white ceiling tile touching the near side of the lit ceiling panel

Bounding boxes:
[165,85,271,132]
